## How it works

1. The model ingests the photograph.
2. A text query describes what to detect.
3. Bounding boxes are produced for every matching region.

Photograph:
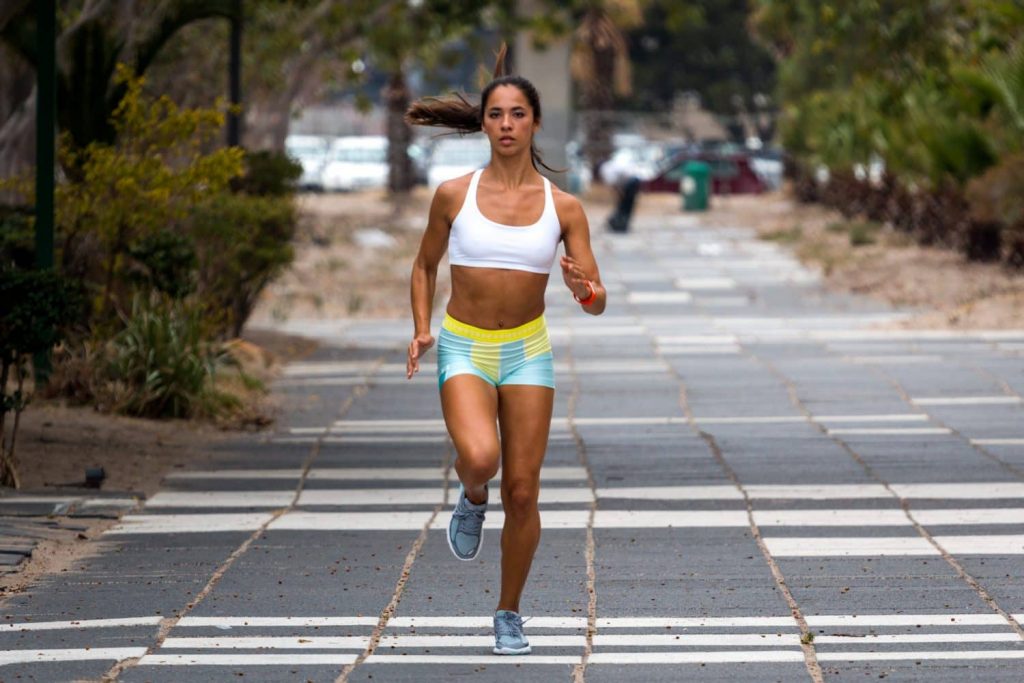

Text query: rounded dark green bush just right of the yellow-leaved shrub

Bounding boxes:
[189,195,296,337]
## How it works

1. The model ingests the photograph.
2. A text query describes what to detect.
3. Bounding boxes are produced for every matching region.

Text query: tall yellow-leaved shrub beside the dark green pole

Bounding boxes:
[56,67,243,311]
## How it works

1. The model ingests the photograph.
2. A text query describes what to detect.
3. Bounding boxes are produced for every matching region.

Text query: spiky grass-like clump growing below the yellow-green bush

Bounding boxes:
[108,296,232,418]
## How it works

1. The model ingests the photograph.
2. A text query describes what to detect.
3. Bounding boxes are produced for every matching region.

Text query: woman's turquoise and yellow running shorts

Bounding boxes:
[437,314,555,389]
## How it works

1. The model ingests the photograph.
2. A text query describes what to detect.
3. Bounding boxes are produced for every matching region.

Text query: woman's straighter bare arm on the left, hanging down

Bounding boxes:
[406,182,452,379]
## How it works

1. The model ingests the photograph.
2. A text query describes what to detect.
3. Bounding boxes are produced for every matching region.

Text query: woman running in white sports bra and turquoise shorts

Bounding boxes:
[407,46,606,654]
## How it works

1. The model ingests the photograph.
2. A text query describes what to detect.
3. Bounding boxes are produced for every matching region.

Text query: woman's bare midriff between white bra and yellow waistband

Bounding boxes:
[447,265,548,330]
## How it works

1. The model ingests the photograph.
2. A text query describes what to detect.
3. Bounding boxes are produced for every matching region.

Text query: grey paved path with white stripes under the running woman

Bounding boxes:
[0,210,1024,683]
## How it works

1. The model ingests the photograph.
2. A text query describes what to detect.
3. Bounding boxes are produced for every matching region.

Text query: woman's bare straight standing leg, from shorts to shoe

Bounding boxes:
[498,384,555,612]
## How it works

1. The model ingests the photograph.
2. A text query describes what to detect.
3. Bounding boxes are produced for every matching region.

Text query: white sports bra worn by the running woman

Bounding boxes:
[449,169,562,274]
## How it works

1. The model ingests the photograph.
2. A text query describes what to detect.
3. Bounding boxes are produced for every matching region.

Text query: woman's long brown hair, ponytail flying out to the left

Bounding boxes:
[406,42,564,173]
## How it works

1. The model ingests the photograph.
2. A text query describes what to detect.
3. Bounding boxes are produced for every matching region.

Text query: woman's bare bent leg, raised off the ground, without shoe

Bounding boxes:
[441,374,501,504]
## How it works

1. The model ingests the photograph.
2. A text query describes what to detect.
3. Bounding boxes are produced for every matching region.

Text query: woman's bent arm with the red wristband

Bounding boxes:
[556,193,608,315]
